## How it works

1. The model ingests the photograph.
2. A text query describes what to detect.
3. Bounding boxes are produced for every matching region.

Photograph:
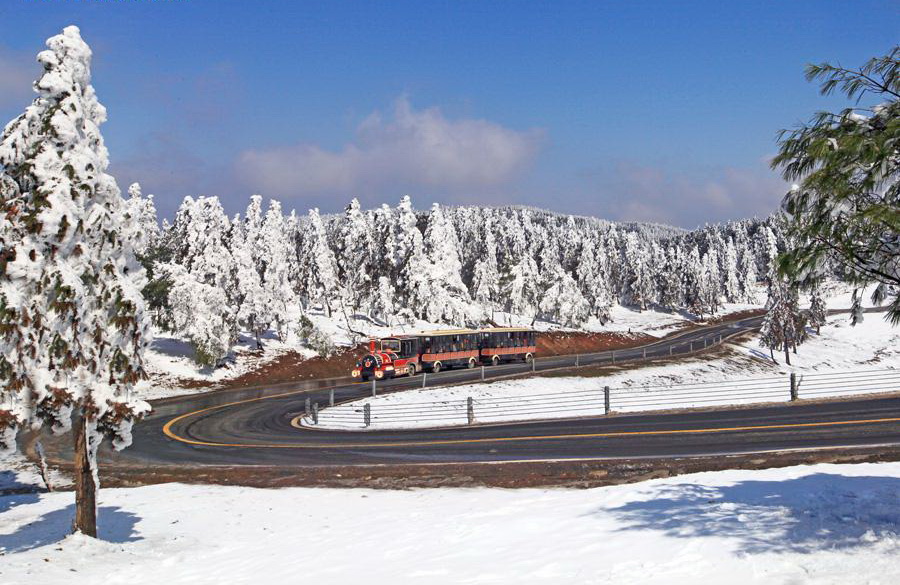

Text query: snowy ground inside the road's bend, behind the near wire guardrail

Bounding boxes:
[302,288,900,429]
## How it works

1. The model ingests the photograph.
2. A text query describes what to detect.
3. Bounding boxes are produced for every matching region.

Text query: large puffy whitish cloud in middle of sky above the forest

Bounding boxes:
[237,97,542,197]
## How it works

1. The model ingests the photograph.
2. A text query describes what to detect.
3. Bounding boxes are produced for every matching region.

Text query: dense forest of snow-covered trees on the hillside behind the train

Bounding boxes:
[128,189,783,365]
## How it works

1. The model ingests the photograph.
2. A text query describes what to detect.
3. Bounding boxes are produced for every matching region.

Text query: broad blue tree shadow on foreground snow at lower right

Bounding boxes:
[592,473,900,554]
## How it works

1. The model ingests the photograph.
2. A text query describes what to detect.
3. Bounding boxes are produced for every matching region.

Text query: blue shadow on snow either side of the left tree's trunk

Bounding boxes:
[0,502,141,554]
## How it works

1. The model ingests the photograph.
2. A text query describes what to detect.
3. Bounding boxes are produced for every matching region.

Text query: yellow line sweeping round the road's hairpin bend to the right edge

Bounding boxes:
[163,405,900,449]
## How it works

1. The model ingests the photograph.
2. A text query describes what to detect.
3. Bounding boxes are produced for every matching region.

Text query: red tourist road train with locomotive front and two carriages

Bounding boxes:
[352,327,537,380]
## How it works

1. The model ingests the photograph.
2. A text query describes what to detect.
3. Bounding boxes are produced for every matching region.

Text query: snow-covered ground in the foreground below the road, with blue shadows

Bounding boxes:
[0,463,900,585]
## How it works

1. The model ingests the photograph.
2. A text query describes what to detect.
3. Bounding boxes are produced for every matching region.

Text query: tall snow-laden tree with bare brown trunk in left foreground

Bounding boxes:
[0,26,150,536]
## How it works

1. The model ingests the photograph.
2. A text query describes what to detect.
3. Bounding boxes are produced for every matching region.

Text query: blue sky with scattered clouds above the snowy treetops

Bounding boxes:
[0,0,900,227]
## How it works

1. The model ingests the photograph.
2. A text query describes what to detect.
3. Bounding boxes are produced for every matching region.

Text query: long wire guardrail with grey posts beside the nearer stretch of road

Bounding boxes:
[303,369,900,429]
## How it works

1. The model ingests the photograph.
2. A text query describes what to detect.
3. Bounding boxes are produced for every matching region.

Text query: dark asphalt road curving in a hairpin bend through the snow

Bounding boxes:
[115,317,900,466]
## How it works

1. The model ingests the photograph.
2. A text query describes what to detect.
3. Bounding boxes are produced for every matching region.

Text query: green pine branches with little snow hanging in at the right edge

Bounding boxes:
[772,45,900,324]
